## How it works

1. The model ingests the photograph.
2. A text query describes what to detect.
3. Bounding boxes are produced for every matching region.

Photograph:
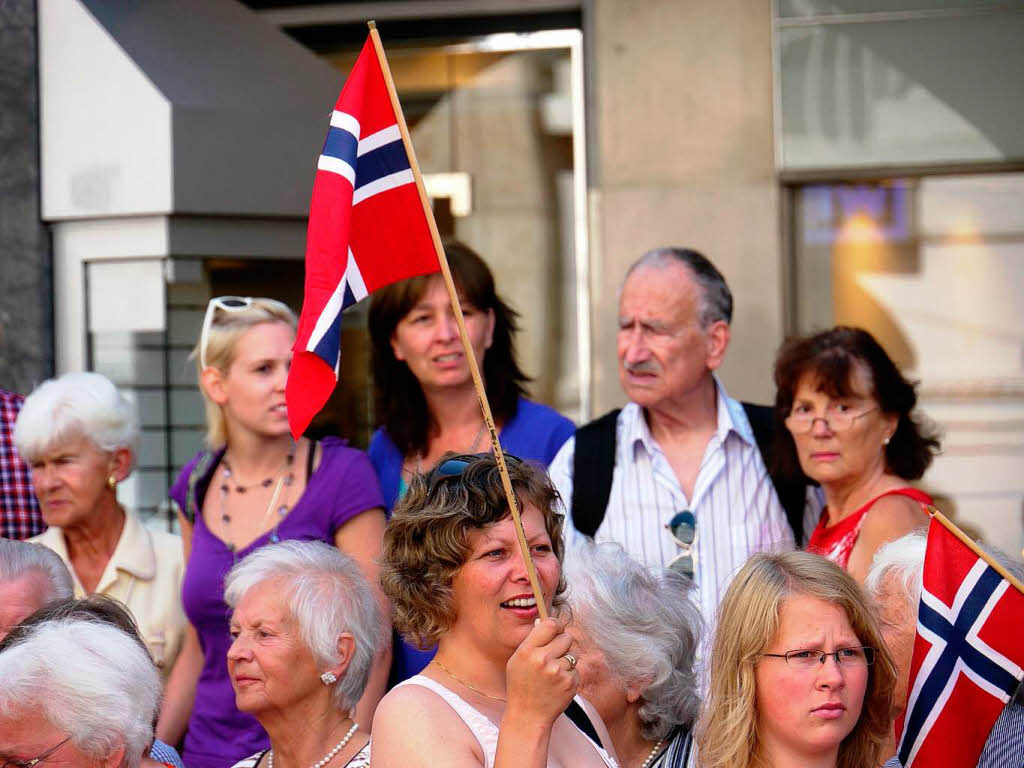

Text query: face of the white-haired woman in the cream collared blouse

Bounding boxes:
[32,435,120,528]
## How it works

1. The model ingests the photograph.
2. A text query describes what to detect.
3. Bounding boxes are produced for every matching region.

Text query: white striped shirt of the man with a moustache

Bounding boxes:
[548,379,795,626]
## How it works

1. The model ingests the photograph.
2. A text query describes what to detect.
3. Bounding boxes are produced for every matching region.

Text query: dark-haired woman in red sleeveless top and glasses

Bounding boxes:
[775,326,939,582]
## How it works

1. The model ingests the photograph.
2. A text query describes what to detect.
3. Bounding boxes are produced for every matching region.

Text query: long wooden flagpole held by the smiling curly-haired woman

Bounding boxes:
[367,20,548,618]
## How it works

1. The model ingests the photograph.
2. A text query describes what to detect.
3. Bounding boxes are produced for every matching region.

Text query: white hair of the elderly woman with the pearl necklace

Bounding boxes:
[224,541,384,710]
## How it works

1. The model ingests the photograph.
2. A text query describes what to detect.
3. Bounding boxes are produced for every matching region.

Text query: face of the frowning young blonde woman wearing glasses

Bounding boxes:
[755,595,868,757]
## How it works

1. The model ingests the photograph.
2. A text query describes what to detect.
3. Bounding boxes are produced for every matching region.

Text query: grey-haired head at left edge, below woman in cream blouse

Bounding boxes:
[0,539,74,640]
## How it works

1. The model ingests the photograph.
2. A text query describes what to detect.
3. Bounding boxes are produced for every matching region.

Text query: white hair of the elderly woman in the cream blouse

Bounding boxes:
[14,373,139,464]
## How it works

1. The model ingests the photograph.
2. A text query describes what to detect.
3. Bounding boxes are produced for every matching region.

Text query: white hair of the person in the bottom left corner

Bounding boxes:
[0,618,161,768]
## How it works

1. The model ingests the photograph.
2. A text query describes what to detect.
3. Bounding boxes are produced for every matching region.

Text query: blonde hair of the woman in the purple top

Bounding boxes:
[189,298,298,449]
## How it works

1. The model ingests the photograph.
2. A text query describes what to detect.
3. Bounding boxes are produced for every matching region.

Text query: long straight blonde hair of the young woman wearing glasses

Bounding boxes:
[698,552,896,768]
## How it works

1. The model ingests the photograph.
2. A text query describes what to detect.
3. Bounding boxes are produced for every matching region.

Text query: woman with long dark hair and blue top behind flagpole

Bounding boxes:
[369,242,574,679]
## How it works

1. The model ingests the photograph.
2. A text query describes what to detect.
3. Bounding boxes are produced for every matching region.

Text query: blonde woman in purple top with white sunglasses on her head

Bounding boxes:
[158,297,390,768]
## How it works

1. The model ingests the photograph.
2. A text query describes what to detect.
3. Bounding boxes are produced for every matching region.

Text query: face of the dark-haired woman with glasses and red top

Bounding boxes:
[786,365,897,485]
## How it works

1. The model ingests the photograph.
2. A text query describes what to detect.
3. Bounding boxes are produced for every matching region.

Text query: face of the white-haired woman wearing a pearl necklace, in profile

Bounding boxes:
[227,579,327,718]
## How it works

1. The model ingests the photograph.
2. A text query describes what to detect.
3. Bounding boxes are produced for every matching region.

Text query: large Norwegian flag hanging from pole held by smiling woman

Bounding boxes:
[286,38,440,438]
